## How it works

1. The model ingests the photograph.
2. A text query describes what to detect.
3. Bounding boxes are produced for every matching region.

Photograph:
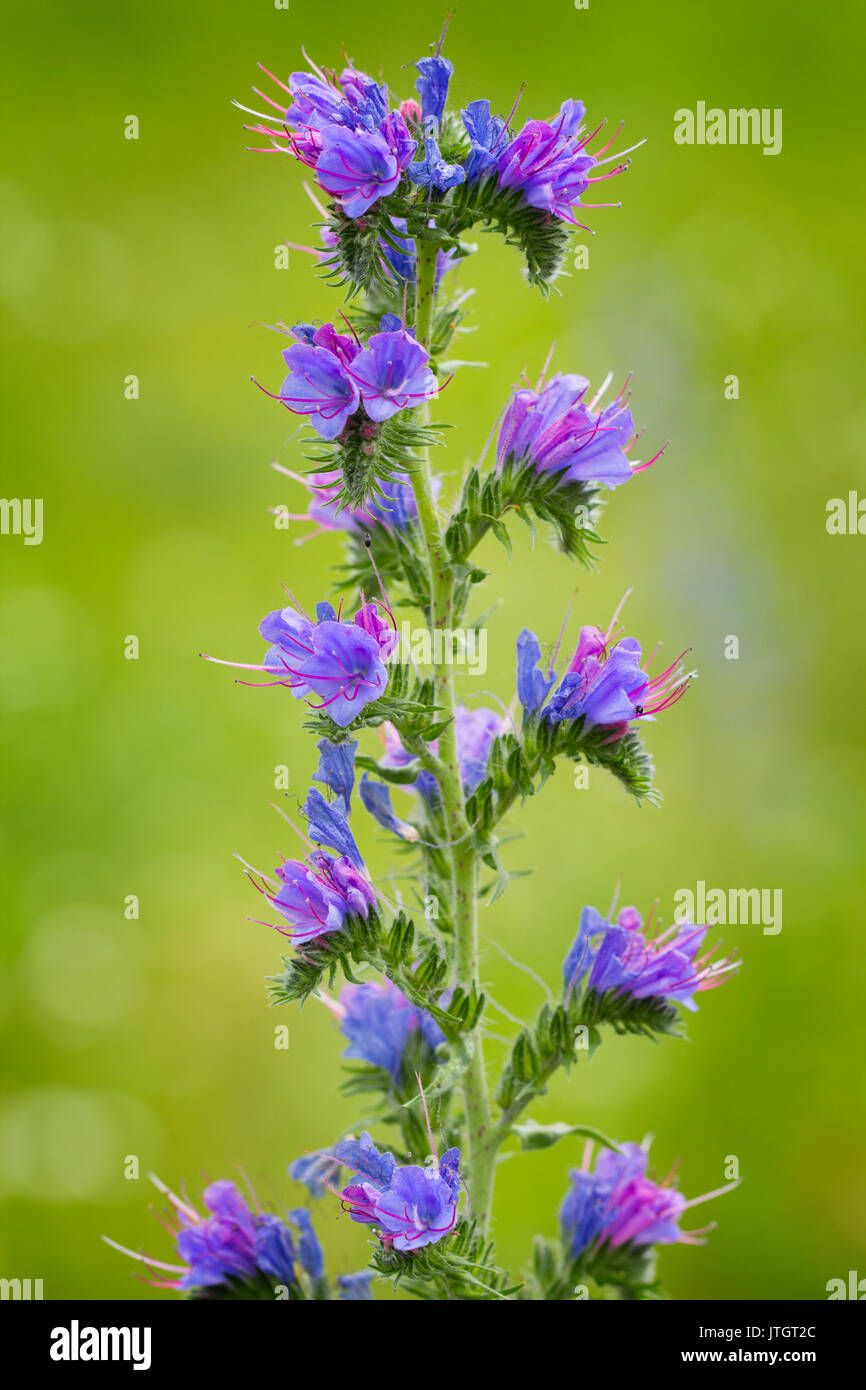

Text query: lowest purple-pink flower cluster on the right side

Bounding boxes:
[559,1144,737,1259]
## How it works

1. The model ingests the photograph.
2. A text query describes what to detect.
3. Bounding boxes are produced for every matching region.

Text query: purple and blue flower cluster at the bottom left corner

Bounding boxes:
[103,1177,370,1300]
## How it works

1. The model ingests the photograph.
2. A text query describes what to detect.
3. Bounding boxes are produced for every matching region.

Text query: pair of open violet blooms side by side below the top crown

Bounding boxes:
[279,314,438,439]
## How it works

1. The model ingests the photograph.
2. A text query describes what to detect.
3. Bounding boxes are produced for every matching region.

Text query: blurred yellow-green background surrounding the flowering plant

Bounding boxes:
[0,0,866,1298]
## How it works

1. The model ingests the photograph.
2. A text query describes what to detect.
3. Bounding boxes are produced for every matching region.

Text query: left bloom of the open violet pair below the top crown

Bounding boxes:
[279,324,360,439]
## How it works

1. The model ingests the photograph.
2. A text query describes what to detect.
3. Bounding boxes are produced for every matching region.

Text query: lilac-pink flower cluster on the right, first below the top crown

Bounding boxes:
[496,373,664,488]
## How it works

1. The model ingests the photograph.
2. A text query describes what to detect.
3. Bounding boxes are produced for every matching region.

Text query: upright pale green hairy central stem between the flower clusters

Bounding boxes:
[411,239,496,1232]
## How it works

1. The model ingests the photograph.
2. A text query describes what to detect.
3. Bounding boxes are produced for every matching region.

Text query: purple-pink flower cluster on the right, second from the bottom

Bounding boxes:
[563,908,740,1012]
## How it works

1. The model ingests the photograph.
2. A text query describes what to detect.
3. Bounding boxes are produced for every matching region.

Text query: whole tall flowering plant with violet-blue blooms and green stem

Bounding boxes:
[104,29,738,1300]
